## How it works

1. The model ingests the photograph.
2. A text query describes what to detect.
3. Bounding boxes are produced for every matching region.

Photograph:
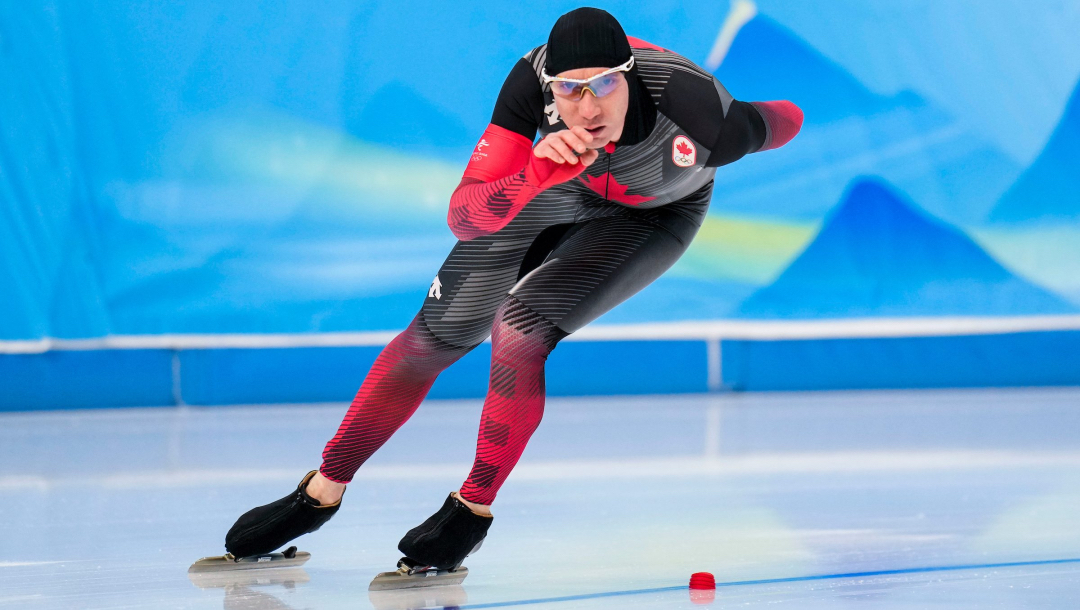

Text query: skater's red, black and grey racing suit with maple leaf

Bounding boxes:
[321,38,802,504]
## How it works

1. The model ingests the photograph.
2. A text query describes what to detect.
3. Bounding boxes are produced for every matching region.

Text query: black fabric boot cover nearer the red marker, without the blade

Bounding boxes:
[397,493,492,570]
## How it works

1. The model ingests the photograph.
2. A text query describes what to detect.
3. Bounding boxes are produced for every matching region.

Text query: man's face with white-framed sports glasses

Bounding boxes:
[554,68,630,148]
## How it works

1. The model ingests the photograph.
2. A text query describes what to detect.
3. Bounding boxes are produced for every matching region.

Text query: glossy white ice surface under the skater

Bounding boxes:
[0,389,1080,610]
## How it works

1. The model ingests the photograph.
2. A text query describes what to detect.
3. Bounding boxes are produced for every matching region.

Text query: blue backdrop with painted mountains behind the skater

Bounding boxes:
[6,0,1080,340]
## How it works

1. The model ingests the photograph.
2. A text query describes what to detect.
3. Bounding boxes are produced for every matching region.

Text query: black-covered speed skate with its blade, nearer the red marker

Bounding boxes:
[368,493,492,591]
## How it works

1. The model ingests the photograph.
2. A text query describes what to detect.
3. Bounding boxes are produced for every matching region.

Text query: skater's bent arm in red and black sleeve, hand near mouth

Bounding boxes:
[446,58,596,240]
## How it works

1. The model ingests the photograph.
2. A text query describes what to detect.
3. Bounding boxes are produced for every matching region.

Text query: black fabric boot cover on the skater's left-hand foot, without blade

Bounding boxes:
[225,471,341,557]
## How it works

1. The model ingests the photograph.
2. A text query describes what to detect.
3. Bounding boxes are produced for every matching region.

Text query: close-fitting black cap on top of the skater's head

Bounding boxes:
[546,6,632,77]
